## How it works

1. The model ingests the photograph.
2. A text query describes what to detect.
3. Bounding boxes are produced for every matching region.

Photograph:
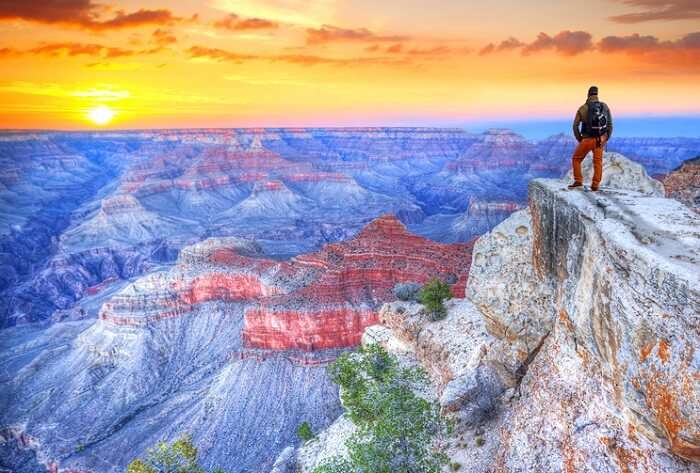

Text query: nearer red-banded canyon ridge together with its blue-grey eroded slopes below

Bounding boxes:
[0,215,471,473]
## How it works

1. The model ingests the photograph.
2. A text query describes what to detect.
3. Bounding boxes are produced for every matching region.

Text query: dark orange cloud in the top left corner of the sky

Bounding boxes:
[0,0,182,31]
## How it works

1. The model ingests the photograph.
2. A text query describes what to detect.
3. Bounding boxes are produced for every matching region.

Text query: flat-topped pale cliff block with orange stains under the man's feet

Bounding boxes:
[530,177,700,461]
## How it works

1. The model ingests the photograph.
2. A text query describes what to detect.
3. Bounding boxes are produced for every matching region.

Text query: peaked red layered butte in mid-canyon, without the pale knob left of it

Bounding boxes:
[243,216,472,351]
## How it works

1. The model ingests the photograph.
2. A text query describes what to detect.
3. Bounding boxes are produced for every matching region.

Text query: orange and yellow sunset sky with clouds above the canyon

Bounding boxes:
[0,0,700,136]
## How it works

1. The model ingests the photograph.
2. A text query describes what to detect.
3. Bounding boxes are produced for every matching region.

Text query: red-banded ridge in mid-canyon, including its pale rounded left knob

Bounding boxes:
[100,215,472,352]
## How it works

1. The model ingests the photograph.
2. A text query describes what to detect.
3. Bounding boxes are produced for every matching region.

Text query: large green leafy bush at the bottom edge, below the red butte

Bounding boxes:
[314,345,450,473]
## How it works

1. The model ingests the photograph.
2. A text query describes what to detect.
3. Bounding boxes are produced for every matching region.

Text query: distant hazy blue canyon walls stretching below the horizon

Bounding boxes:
[5,128,700,326]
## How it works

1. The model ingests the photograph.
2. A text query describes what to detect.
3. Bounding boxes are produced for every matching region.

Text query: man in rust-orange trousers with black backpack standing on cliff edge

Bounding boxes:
[569,86,612,192]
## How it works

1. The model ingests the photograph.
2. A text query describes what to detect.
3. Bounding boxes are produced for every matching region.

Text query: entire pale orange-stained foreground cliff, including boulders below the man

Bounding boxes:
[290,156,700,472]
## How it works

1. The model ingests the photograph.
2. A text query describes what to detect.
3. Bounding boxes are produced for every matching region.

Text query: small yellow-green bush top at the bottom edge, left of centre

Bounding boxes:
[126,434,224,473]
